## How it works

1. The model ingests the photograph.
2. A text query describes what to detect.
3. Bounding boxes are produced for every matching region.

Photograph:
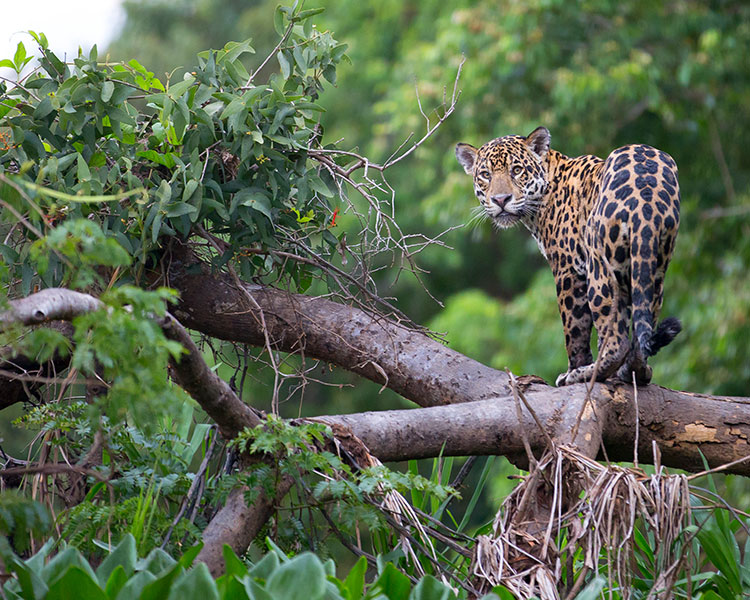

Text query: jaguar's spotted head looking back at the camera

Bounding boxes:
[456,127,550,228]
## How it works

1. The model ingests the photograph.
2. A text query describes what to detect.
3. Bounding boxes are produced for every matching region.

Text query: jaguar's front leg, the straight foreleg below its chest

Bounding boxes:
[555,270,593,386]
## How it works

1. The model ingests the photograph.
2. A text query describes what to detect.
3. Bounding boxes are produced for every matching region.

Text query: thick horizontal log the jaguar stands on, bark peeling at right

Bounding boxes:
[316,383,750,476]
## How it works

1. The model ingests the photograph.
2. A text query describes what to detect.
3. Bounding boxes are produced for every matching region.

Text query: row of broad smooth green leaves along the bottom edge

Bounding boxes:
[0,535,508,600]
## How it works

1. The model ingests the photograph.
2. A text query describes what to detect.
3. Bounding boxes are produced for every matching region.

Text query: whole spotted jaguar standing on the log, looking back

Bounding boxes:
[456,127,681,385]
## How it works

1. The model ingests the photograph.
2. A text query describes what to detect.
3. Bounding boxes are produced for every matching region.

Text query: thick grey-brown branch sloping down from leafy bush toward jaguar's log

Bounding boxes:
[168,245,511,406]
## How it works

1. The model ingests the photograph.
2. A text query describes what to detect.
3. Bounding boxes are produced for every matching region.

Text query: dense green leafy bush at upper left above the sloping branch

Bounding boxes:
[0,8,346,293]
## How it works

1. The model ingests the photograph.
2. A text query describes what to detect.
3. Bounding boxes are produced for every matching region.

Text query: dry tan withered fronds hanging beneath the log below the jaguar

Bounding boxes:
[473,446,691,600]
